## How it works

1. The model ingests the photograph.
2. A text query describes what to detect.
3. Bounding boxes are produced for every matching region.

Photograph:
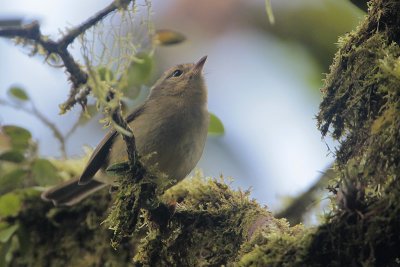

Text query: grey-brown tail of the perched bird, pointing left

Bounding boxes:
[42,178,106,206]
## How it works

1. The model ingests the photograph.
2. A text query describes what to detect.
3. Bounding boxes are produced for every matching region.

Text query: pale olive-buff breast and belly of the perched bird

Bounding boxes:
[109,102,208,184]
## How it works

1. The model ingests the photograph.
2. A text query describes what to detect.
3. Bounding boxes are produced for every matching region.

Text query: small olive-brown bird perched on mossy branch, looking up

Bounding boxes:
[41,56,209,206]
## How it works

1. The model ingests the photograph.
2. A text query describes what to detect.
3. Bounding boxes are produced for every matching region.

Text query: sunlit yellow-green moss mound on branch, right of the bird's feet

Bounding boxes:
[135,176,279,266]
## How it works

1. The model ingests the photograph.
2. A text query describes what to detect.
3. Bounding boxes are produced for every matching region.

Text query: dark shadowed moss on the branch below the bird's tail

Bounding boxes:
[8,191,133,267]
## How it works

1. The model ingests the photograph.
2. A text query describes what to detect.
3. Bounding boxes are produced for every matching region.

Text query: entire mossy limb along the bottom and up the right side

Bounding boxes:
[2,0,400,266]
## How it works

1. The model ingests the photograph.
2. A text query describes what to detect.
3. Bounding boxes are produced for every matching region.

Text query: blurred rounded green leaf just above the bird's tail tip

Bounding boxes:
[32,159,62,186]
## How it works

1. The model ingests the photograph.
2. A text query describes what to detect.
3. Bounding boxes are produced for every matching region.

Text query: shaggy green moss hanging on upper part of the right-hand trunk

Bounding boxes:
[317,1,400,191]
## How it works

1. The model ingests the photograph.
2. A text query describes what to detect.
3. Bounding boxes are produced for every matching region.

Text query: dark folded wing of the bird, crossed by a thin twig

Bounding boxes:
[79,105,144,185]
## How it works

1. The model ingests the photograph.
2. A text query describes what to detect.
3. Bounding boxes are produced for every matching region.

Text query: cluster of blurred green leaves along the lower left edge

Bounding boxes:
[0,122,66,266]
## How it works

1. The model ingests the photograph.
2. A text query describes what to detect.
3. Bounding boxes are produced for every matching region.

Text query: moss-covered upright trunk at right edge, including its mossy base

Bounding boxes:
[239,0,400,266]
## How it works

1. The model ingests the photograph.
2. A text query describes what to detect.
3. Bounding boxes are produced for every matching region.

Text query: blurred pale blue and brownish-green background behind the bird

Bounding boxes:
[0,0,364,214]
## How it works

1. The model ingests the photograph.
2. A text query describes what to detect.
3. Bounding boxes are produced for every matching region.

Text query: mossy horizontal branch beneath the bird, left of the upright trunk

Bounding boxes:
[6,177,282,266]
